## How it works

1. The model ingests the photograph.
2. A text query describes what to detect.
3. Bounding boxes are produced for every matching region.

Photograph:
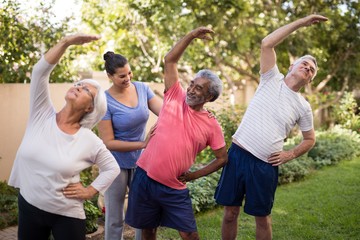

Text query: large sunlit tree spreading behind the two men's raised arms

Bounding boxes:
[83,0,360,107]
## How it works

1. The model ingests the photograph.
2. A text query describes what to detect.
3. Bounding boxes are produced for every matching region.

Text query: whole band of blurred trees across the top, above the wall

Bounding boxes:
[0,0,360,91]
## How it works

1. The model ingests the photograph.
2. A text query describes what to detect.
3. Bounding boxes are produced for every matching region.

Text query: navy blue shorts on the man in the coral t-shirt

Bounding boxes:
[125,167,197,232]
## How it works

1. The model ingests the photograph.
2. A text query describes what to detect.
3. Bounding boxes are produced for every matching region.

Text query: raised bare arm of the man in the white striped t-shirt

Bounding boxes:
[260,14,328,73]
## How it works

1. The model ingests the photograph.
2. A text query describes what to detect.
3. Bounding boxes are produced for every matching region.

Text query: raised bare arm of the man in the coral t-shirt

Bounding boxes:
[164,27,214,92]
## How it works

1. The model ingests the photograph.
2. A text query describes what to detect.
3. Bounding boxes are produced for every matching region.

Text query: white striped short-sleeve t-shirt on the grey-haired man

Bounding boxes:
[233,65,313,162]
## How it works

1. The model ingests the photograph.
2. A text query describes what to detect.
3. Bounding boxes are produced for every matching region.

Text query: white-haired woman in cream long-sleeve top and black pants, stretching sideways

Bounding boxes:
[9,34,120,240]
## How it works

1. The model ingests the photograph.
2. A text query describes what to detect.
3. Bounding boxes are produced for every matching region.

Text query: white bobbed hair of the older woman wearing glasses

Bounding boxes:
[79,79,107,129]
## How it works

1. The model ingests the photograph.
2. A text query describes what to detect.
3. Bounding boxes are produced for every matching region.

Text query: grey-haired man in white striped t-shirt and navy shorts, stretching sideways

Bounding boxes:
[215,15,327,240]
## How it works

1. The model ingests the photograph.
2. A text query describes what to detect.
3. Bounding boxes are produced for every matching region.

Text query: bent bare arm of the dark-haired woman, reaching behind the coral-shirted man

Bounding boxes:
[98,120,148,152]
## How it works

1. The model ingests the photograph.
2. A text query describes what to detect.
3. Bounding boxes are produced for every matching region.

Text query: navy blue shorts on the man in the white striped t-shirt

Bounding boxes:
[215,143,278,216]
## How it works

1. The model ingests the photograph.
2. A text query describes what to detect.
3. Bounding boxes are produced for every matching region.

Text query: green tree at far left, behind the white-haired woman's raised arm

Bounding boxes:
[0,0,79,83]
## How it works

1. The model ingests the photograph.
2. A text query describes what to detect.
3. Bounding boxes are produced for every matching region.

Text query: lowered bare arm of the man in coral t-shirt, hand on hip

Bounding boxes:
[178,146,228,183]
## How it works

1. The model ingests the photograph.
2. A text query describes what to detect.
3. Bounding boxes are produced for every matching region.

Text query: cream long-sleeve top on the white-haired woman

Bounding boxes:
[9,57,120,219]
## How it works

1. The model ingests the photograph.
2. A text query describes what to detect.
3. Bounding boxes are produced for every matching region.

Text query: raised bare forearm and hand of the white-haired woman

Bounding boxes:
[45,33,100,64]
